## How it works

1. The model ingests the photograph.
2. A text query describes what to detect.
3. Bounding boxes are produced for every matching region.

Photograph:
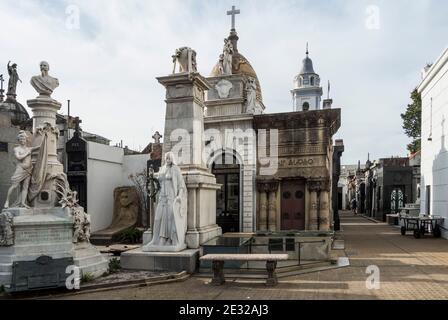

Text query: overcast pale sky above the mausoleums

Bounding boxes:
[0,0,448,164]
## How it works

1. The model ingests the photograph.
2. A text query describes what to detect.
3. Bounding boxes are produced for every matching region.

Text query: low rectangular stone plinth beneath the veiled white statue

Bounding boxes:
[120,248,199,274]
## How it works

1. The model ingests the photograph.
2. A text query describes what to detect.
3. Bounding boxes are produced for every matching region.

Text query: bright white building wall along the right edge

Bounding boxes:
[419,49,448,238]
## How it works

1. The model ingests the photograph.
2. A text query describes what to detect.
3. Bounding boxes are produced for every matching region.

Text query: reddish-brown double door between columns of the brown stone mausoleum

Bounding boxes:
[281,180,305,230]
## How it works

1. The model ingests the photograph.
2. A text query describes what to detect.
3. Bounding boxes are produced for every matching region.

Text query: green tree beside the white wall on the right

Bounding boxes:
[401,89,422,153]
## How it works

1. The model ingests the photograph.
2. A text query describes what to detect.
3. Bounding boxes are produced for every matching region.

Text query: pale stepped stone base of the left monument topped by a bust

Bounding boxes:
[0,208,108,288]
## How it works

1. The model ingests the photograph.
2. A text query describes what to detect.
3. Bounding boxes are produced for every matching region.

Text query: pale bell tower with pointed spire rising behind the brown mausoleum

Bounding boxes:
[291,43,323,111]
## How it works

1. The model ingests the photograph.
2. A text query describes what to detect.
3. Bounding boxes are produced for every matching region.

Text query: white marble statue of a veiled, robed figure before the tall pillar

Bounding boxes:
[143,152,187,252]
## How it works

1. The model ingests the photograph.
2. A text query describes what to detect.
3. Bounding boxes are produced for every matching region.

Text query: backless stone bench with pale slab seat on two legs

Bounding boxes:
[200,254,288,286]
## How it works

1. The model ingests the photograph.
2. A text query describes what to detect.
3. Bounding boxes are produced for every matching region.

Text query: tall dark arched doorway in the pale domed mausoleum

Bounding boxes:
[212,152,242,233]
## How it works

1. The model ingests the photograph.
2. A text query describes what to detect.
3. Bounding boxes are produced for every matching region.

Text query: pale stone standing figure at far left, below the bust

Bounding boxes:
[4,130,39,209]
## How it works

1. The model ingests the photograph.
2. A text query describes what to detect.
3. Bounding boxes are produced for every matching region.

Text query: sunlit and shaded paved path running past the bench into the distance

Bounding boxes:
[57,213,448,300]
